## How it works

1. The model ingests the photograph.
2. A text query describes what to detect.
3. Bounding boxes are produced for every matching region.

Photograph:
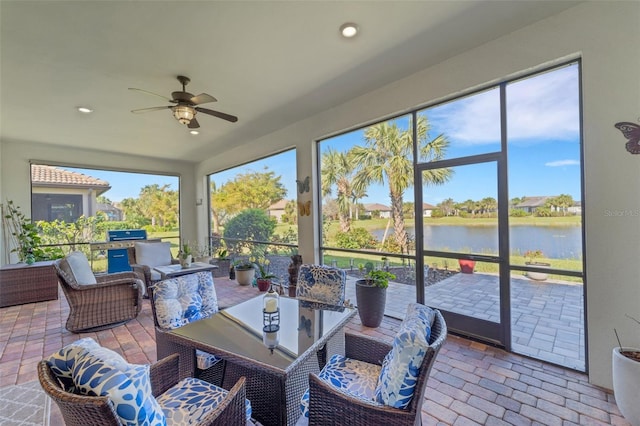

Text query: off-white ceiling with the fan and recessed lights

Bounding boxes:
[0,0,576,162]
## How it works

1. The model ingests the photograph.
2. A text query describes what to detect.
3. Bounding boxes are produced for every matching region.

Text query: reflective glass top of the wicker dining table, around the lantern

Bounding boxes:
[171,296,355,370]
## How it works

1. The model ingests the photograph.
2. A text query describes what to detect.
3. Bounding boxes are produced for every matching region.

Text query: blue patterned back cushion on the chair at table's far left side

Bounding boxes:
[153,272,218,330]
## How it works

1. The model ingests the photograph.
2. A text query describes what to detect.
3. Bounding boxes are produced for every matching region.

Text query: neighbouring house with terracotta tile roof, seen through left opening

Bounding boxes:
[31,164,111,222]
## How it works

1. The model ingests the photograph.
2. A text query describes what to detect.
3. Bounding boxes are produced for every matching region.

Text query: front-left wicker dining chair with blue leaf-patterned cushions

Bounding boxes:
[38,338,253,426]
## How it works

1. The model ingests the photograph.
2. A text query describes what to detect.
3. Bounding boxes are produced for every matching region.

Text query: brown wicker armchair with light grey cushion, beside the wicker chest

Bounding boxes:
[54,253,144,333]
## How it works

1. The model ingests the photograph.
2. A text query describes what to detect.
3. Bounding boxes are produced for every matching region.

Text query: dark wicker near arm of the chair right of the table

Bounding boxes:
[309,374,415,426]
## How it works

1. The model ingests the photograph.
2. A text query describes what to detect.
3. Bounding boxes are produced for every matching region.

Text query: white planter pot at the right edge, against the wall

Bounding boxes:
[612,348,640,426]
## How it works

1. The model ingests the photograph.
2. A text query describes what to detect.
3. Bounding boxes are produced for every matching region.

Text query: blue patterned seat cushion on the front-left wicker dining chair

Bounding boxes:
[158,377,251,425]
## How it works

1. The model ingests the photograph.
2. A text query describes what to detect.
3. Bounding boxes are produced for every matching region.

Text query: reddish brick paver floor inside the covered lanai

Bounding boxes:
[0,278,629,426]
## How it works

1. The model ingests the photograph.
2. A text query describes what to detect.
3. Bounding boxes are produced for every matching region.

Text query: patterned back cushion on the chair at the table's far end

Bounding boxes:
[296,265,347,306]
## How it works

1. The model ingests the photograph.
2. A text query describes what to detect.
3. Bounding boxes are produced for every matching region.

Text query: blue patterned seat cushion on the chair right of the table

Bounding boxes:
[300,354,380,417]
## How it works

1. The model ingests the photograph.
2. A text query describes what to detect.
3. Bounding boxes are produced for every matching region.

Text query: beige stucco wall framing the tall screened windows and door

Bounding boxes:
[196,2,640,388]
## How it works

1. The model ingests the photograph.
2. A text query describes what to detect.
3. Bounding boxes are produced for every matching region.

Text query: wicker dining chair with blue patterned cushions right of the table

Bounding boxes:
[297,303,447,426]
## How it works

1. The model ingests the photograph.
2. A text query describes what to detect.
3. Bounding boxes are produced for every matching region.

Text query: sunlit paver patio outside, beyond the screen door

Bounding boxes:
[346,273,585,371]
